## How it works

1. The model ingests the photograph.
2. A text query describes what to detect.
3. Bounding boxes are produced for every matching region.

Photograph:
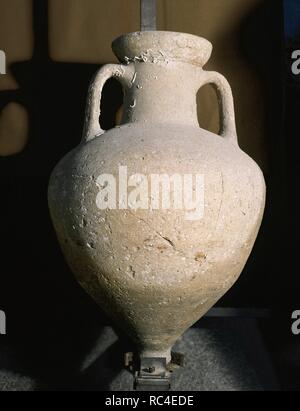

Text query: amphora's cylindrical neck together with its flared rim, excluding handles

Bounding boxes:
[112,31,212,126]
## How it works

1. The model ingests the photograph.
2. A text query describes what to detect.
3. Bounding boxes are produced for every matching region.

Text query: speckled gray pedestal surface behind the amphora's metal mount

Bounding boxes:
[0,320,278,391]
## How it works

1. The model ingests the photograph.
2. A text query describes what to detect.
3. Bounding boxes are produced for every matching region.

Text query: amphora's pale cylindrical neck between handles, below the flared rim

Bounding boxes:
[122,62,201,126]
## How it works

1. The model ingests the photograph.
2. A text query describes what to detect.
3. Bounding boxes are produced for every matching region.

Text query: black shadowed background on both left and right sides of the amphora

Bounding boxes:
[0,0,300,389]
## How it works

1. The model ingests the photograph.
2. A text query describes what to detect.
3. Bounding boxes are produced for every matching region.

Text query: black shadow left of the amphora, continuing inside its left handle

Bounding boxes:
[0,0,122,384]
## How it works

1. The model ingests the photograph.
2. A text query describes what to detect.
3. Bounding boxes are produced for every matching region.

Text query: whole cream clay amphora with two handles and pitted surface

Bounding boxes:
[49,32,265,355]
